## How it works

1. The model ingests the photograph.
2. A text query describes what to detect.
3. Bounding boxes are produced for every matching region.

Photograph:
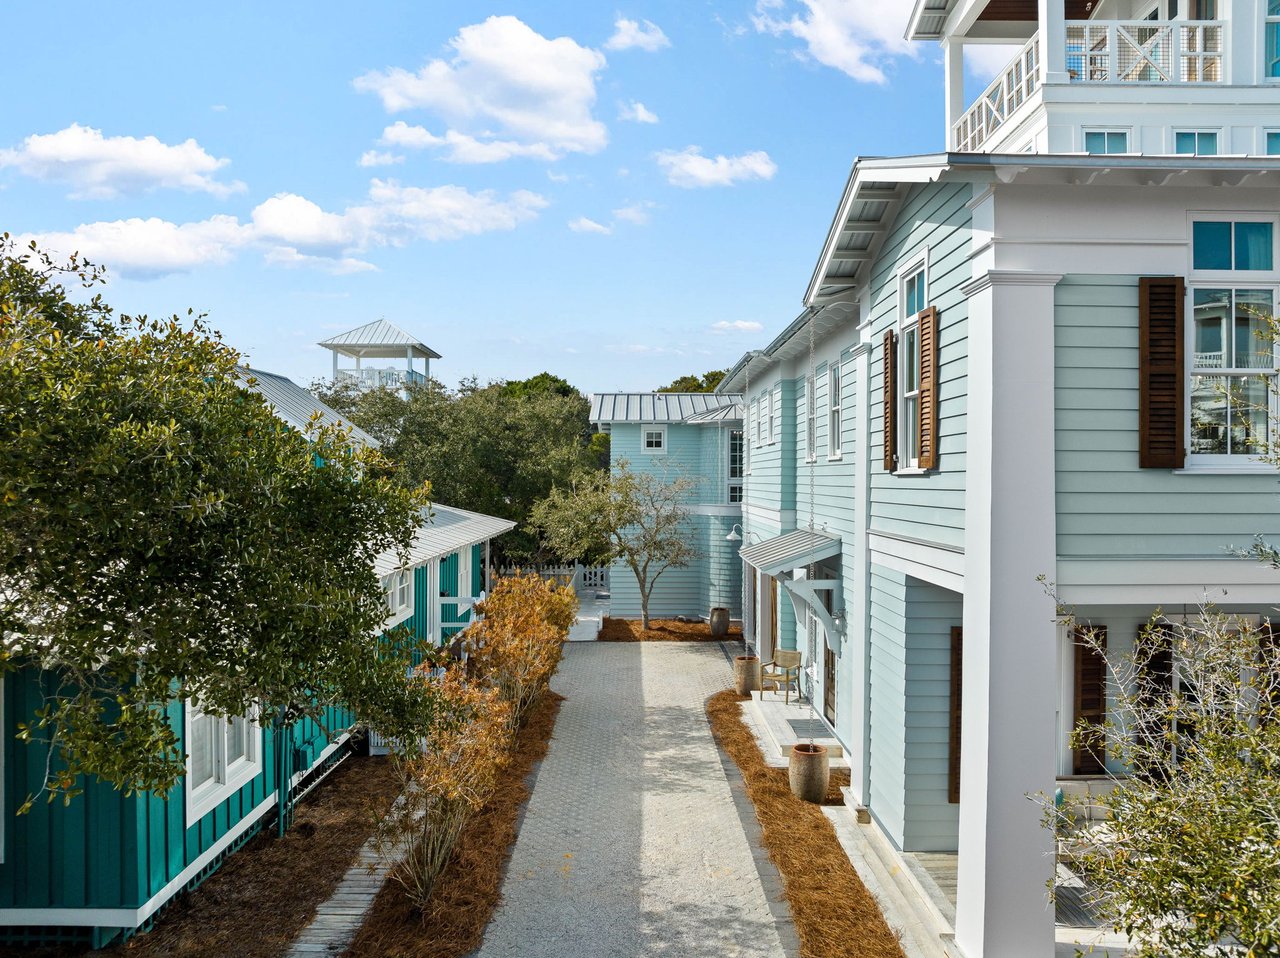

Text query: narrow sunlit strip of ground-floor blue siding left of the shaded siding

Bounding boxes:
[868,566,906,845]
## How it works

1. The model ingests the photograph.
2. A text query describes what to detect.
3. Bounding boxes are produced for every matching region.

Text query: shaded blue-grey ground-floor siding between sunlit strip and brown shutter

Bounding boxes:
[902,578,964,852]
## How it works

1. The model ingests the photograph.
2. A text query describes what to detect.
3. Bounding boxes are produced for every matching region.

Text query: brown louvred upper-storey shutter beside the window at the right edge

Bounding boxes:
[1138,277,1187,469]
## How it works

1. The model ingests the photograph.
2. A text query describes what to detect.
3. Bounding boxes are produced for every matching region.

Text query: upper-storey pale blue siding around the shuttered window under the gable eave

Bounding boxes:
[867,184,973,547]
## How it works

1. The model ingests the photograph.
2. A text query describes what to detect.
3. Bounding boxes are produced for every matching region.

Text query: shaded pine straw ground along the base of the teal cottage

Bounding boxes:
[117,756,399,958]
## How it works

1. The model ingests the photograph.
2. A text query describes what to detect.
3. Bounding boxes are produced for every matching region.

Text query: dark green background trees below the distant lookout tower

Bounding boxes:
[314,373,608,562]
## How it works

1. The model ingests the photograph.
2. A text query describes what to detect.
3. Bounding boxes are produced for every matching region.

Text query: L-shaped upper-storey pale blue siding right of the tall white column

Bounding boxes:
[1055,275,1280,558]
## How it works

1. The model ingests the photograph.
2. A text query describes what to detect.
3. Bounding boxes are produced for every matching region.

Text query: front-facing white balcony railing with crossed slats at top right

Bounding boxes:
[1066,20,1224,83]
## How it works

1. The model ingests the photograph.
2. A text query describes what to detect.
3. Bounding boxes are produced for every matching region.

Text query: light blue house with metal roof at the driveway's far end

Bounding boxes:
[591,392,745,619]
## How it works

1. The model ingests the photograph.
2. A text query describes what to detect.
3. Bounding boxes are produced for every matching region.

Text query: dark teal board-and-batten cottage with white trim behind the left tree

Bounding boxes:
[0,370,512,946]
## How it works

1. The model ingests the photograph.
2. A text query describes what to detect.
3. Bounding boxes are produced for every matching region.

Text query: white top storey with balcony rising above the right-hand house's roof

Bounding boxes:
[908,0,1280,156]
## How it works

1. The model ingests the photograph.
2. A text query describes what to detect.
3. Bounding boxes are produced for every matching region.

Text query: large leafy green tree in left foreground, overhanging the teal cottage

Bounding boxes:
[0,237,426,798]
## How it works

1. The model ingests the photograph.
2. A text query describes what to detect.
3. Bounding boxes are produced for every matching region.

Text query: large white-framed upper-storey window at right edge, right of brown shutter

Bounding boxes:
[1187,215,1280,465]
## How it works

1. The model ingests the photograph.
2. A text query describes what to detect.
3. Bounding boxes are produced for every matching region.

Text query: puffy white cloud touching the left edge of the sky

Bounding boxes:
[0,123,244,200]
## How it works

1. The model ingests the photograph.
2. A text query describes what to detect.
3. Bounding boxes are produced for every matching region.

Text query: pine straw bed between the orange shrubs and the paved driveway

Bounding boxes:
[344,690,564,958]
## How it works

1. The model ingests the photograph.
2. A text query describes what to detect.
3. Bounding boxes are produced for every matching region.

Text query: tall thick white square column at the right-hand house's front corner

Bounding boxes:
[956,270,1061,958]
